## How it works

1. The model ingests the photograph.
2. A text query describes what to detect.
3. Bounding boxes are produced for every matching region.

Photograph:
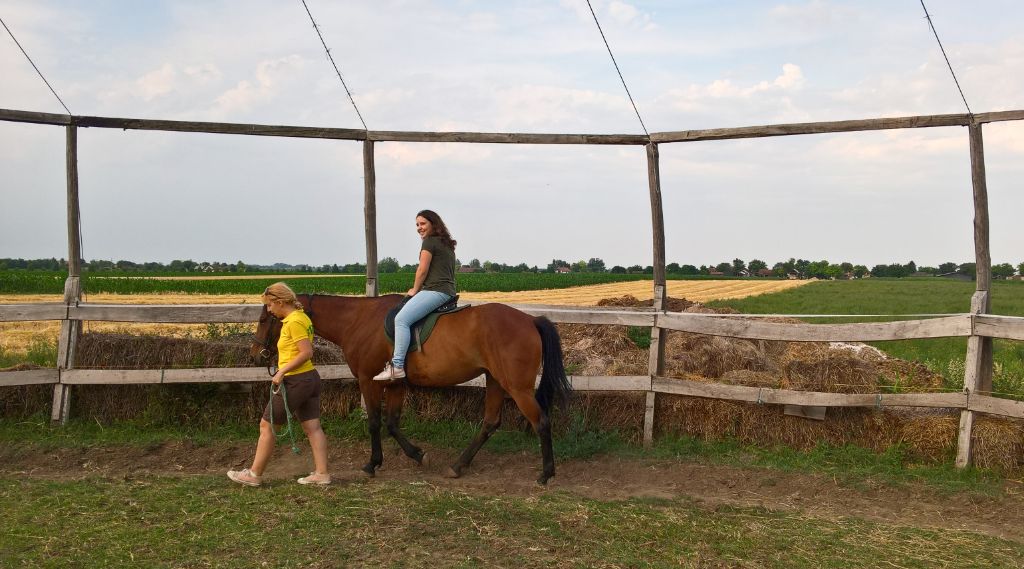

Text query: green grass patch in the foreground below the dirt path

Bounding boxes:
[0,477,1024,568]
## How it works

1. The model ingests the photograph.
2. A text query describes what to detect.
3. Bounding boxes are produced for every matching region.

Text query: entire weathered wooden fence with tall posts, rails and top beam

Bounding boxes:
[0,108,1024,467]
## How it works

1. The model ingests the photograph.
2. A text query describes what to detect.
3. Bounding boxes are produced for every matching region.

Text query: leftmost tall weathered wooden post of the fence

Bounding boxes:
[50,124,82,425]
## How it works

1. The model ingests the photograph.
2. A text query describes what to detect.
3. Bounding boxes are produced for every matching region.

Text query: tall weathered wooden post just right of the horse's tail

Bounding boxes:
[643,142,669,446]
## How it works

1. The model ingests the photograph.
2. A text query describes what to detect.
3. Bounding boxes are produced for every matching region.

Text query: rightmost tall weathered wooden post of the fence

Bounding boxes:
[956,122,992,468]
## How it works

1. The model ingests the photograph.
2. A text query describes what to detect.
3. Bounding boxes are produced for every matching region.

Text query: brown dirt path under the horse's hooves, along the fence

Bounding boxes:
[0,440,1024,541]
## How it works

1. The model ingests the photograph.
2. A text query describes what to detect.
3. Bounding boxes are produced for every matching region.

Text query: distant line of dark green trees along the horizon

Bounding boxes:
[0,257,1024,278]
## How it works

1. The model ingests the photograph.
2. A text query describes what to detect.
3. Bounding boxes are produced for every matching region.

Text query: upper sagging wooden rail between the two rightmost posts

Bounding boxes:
[656,312,971,342]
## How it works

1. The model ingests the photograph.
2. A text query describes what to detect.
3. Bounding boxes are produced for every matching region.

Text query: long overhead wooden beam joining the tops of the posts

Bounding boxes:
[0,108,1024,144]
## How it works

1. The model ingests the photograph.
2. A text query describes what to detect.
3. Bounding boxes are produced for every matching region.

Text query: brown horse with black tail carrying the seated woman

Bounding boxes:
[252,295,572,484]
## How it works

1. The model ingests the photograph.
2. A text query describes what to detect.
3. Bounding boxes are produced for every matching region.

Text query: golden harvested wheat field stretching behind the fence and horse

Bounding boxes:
[0,275,810,353]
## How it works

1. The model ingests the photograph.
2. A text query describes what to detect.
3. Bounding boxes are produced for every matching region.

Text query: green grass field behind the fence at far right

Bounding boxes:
[709,278,1024,398]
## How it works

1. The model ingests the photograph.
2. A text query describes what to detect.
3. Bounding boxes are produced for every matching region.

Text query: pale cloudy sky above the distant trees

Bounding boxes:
[0,0,1024,267]
